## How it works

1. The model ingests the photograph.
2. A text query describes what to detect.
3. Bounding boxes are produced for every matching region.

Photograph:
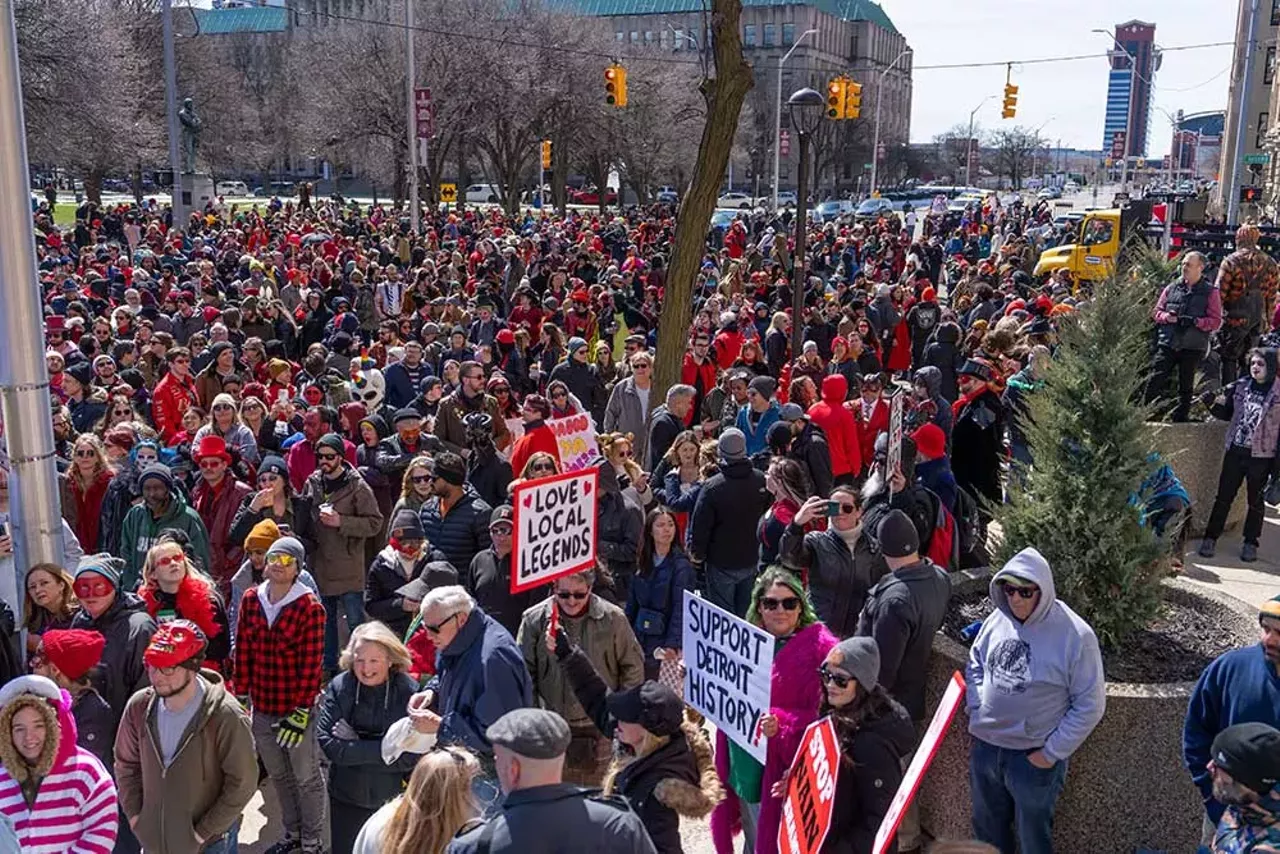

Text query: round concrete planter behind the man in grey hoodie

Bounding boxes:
[920,574,1257,854]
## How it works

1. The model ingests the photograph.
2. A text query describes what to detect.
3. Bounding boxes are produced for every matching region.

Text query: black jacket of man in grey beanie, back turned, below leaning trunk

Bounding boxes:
[689,460,773,570]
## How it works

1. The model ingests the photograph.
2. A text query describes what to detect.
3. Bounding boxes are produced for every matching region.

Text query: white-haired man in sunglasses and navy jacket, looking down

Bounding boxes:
[408,584,534,808]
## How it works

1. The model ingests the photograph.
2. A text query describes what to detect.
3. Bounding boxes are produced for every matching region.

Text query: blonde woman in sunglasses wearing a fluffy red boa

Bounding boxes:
[138,530,232,672]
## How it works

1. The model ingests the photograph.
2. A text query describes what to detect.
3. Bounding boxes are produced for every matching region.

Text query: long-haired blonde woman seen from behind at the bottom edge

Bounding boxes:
[350,746,480,854]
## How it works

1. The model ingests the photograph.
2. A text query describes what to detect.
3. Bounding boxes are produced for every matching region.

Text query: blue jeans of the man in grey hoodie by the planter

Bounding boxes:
[969,739,1066,854]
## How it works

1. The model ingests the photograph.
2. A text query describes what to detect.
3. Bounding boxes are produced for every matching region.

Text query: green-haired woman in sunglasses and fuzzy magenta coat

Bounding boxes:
[712,566,837,854]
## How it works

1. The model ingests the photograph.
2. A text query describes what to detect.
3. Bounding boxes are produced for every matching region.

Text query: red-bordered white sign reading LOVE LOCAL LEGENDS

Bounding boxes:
[511,469,600,593]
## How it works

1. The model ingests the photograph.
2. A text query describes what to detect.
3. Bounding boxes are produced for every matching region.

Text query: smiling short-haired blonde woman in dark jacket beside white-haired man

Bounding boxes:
[316,620,422,851]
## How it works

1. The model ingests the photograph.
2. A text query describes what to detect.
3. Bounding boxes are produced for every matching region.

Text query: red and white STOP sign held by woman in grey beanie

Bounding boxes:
[778,714,840,854]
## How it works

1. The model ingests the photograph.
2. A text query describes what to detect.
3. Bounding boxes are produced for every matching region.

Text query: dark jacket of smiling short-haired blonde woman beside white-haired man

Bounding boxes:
[316,671,420,809]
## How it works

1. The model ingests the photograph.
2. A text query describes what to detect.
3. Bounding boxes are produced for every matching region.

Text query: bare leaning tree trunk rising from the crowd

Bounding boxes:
[649,0,755,401]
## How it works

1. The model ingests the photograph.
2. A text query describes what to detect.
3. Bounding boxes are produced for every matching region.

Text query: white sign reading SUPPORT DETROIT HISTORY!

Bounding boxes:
[681,590,774,763]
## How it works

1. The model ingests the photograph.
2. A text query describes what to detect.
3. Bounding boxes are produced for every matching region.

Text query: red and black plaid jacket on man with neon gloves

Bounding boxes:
[236,588,325,717]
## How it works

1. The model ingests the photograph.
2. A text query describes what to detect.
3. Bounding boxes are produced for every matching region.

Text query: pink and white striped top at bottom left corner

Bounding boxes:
[0,746,119,854]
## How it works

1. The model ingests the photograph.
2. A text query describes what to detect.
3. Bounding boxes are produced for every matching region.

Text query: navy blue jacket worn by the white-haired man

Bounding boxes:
[430,606,534,755]
